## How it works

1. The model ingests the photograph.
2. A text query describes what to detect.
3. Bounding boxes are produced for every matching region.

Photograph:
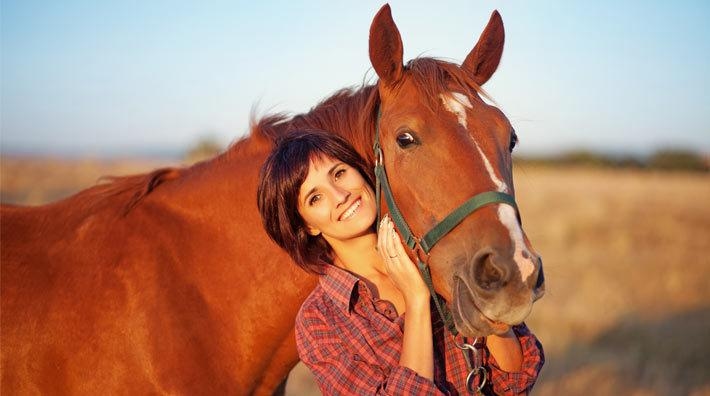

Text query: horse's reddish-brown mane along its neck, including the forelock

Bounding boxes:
[83,57,490,214]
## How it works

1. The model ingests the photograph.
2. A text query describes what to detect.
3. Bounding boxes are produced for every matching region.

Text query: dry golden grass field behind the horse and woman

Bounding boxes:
[0,158,710,395]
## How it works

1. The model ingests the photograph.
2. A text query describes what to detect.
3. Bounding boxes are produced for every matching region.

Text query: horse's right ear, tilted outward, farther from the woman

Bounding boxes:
[461,11,505,85]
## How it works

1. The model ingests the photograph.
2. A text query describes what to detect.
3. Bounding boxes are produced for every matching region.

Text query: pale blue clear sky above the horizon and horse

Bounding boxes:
[0,0,710,155]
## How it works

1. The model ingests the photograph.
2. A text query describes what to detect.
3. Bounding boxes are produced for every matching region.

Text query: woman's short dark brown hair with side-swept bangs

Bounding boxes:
[257,130,374,274]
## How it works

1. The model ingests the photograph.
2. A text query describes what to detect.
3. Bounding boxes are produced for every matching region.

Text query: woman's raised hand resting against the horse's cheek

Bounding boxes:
[377,216,430,305]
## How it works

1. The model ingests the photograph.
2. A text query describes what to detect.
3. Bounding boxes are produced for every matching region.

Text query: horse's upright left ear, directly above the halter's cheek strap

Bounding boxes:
[370,4,403,85]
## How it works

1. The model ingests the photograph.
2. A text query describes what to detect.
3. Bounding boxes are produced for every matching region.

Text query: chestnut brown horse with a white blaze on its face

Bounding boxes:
[1,6,542,395]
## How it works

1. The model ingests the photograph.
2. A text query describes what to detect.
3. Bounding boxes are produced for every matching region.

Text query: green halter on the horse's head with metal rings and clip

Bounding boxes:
[373,107,518,392]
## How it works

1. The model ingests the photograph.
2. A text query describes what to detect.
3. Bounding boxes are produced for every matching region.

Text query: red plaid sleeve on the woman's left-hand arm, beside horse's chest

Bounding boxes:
[296,304,446,395]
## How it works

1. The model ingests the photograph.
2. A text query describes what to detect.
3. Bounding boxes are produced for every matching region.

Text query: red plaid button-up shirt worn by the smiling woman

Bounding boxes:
[296,266,545,395]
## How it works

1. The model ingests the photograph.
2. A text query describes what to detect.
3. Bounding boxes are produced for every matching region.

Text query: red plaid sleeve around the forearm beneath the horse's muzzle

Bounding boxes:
[488,323,545,395]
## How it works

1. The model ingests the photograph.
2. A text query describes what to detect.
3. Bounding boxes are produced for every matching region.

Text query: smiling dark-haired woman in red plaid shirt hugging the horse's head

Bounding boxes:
[258,131,544,395]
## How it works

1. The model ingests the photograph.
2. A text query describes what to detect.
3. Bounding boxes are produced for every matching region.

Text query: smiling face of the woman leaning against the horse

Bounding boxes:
[298,157,377,246]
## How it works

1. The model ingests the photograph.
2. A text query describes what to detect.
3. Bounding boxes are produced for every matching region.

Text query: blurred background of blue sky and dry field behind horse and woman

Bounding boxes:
[0,0,710,395]
